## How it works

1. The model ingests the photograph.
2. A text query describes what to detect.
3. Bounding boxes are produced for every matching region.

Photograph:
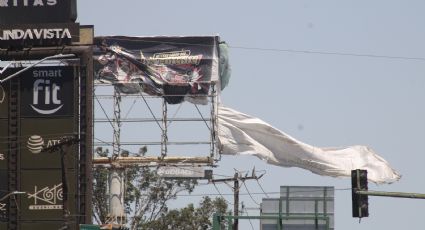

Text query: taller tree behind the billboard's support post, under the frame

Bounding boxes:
[93,148,197,229]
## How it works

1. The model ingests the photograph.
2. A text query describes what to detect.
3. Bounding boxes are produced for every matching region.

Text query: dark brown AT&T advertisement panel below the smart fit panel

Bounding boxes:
[20,118,74,169]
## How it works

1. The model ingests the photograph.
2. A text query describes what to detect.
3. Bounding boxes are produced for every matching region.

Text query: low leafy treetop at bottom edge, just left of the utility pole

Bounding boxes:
[138,197,228,230]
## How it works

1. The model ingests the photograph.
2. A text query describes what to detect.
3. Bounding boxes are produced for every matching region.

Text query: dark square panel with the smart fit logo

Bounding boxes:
[20,66,74,117]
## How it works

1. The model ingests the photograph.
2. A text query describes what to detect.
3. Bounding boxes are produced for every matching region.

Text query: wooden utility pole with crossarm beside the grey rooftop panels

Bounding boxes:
[210,168,264,230]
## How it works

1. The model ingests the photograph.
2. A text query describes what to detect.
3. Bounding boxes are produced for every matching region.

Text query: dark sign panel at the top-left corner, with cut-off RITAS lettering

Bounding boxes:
[0,0,77,25]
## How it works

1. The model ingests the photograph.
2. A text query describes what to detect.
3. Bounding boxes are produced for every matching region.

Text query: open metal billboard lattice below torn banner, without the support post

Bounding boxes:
[93,83,219,167]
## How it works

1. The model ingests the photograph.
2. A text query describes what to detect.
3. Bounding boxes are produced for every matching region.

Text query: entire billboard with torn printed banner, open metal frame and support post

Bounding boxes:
[89,37,220,226]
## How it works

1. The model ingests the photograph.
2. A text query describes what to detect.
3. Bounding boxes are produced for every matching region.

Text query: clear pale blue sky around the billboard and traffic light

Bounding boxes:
[78,0,425,230]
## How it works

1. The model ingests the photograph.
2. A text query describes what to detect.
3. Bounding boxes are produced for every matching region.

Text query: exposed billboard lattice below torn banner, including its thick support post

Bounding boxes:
[93,84,219,226]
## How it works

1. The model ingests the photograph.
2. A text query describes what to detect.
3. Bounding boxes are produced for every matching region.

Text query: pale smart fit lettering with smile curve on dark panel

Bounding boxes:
[30,69,63,115]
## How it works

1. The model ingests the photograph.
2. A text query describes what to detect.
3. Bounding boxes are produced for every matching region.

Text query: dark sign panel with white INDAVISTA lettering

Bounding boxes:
[0,22,80,48]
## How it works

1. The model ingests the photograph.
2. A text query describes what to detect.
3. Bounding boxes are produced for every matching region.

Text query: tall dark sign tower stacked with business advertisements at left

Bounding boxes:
[0,0,93,230]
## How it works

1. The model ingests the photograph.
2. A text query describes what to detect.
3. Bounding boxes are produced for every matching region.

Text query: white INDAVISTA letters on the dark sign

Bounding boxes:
[0,27,72,41]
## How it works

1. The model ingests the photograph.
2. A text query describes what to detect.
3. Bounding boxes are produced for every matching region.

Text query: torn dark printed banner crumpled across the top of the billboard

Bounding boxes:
[94,36,219,104]
